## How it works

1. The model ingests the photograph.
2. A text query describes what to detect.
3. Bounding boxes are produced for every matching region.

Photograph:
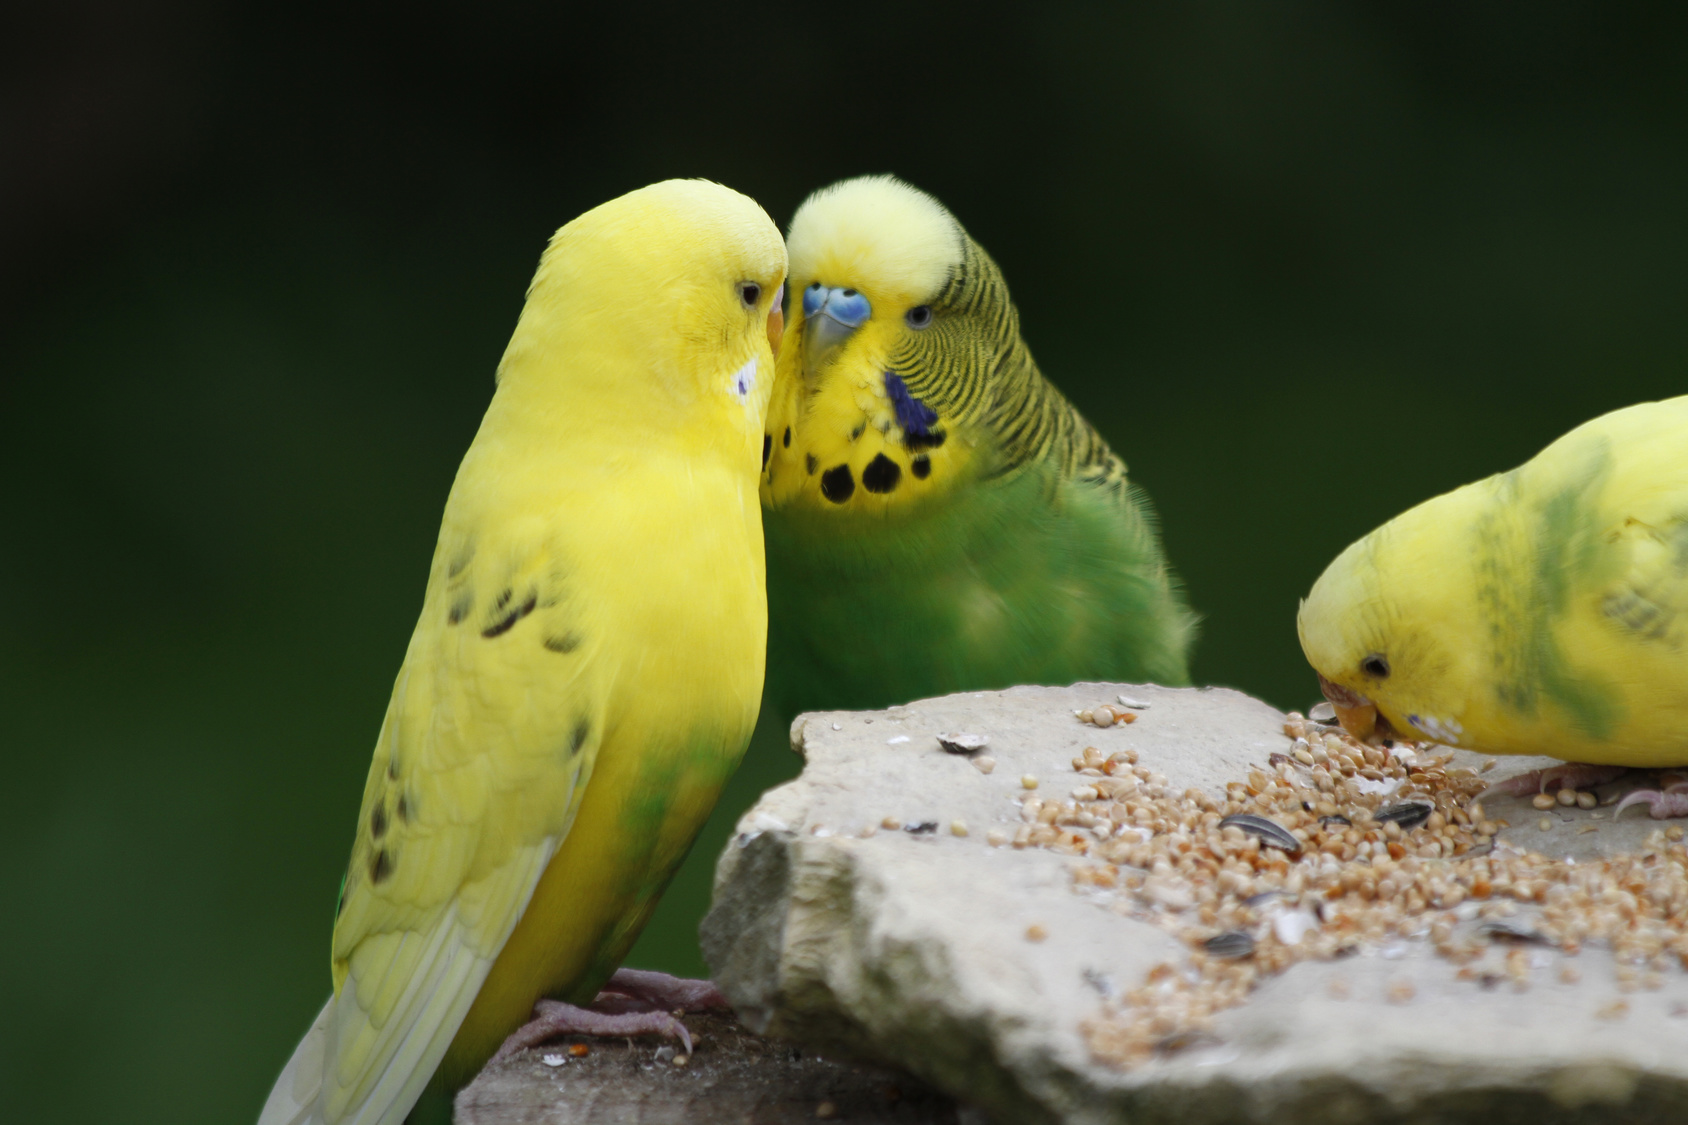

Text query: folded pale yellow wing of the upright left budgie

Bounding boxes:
[319,524,606,1125]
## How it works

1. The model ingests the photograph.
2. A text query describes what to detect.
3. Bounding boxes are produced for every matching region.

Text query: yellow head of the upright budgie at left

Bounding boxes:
[498,179,785,446]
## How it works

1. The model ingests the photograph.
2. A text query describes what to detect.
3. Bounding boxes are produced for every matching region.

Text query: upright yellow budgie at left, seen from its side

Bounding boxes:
[262,181,785,1125]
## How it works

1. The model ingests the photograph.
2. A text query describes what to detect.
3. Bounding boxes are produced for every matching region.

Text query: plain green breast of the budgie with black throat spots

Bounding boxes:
[766,459,1193,715]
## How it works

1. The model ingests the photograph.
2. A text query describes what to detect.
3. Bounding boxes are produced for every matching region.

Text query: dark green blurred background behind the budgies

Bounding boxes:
[0,0,1688,1123]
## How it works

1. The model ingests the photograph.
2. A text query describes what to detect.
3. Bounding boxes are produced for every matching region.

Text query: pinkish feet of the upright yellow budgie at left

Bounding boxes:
[493,970,729,1063]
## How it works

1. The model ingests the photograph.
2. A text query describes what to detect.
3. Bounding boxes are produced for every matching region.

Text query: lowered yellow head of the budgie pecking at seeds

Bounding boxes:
[1296,485,1485,745]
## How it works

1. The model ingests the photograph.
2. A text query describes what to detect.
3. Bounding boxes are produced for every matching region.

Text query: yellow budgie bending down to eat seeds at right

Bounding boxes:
[1296,397,1688,811]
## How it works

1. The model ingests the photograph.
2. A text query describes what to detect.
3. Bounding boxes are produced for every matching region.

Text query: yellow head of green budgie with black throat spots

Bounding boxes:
[761,176,1065,514]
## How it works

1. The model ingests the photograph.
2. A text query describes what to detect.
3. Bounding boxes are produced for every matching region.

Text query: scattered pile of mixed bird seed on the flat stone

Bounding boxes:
[989,713,1688,1068]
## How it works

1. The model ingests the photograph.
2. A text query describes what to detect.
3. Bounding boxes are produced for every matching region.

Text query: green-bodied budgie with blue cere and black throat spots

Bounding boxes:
[761,176,1195,715]
